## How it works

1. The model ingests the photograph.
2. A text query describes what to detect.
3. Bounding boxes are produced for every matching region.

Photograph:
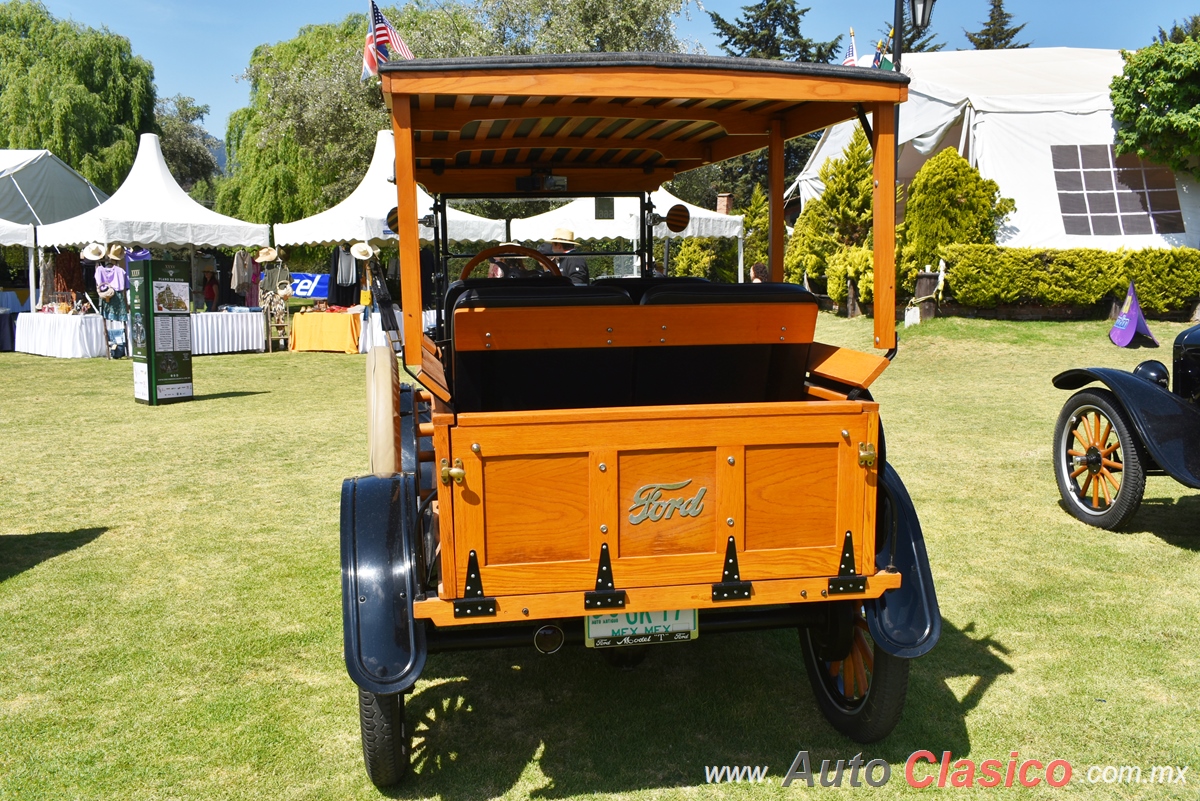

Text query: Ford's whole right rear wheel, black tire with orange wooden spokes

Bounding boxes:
[800,606,908,742]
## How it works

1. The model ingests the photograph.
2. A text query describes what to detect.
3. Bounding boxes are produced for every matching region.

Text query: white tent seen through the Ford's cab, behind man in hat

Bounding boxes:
[511,187,745,281]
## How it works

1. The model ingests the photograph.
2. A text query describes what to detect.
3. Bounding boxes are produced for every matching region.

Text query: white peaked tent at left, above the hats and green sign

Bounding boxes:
[37,133,270,247]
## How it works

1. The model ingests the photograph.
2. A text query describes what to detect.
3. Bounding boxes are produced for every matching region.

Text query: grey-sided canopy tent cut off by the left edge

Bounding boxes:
[0,150,108,308]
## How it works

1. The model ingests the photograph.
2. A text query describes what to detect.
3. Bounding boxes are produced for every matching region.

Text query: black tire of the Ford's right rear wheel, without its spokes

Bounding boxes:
[800,628,908,743]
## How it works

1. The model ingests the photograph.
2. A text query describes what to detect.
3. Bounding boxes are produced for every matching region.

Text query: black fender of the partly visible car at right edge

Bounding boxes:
[1054,367,1200,489]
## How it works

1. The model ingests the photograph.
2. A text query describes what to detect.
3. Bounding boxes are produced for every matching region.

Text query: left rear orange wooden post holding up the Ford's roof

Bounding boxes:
[391,95,425,372]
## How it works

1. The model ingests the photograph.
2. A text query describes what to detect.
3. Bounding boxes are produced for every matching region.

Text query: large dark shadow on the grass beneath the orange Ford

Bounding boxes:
[390,622,1012,801]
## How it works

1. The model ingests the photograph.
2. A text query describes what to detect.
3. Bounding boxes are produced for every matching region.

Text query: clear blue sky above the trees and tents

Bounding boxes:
[44,0,1200,138]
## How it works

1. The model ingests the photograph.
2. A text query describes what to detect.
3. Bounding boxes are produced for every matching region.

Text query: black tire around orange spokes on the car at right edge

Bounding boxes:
[1054,389,1146,530]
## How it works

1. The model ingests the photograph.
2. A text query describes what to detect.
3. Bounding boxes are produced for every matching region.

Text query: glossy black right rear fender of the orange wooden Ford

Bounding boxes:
[865,462,942,660]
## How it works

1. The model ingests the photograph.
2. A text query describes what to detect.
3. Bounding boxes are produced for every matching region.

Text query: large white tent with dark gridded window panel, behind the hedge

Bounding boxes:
[788,48,1200,249]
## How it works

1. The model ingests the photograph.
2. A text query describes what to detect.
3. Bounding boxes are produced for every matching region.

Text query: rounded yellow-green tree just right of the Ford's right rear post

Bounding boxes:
[901,147,1016,291]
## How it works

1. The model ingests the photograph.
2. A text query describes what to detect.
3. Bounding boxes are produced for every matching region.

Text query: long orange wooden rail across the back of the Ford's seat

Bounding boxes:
[454,303,817,351]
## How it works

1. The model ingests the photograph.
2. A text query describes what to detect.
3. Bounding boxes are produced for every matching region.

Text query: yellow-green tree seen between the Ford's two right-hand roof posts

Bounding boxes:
[784,127,875,282]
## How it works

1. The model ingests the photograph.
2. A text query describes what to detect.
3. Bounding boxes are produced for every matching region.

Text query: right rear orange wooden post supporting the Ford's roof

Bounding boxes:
[871,103,896,350]
